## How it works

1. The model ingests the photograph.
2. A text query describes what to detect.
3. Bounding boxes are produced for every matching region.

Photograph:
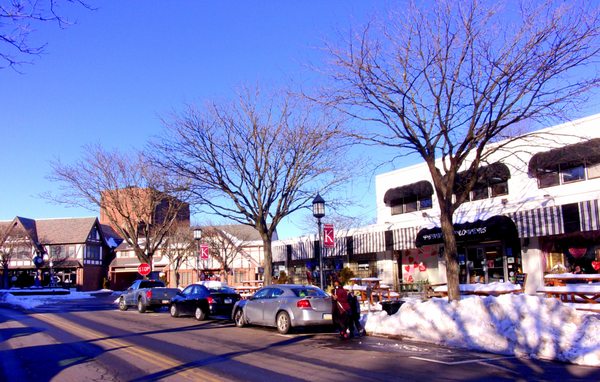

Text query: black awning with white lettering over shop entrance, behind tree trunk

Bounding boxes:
[415,215,518,247]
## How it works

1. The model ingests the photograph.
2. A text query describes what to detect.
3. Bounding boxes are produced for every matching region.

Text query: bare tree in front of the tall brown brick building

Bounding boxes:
[45,146,189,265]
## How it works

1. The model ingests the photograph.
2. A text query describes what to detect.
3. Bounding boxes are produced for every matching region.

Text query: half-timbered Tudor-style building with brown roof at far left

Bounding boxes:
[0,216,119,290]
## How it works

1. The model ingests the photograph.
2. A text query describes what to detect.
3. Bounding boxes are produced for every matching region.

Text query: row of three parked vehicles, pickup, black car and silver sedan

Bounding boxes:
[119,280,332,334]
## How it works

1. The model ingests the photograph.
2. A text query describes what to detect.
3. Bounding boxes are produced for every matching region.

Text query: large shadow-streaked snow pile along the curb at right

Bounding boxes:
[365,294,600,366]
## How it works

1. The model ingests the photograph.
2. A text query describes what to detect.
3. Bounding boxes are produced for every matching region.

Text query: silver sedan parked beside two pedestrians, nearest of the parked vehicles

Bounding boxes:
[232,284,332,334]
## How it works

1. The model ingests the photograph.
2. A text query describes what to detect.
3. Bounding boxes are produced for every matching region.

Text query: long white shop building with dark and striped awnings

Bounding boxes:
[274,115,600,293]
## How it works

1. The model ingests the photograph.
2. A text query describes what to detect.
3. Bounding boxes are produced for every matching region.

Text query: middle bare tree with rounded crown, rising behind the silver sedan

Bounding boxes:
[156,92,351,284]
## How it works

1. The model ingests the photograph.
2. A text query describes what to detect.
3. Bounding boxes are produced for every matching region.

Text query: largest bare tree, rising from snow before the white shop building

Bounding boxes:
[324,0,600,300]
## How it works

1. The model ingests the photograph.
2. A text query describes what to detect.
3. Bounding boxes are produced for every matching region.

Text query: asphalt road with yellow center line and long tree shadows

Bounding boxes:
[0,296,600,382]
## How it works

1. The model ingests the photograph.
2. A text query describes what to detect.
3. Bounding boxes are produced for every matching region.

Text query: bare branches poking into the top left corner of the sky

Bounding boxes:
[0,0,91,68]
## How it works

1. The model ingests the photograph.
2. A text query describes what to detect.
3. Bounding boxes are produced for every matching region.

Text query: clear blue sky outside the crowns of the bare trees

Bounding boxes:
[0,0,398,237]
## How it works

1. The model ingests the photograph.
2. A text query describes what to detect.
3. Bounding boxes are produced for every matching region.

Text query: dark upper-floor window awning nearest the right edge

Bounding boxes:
[529,138,600,177]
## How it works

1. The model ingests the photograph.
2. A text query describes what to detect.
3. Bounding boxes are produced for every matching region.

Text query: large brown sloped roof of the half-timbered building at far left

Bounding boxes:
[35,217,97,244]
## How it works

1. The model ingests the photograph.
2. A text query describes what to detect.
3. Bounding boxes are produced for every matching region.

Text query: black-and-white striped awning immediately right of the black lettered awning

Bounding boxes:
[507,206,565,239]
